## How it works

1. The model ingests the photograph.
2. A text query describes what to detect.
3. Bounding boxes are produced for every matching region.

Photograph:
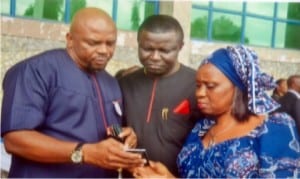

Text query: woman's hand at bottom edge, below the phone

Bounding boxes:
[133,161,175,178]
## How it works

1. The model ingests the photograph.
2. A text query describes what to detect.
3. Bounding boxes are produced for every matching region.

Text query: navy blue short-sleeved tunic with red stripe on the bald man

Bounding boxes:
[1,49,122,178]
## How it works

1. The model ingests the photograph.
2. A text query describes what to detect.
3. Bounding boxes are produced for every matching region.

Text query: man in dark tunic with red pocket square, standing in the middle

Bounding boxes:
[119,15,200,176]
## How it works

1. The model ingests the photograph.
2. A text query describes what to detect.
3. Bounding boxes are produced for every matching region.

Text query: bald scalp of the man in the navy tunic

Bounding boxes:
[70,7,116,33]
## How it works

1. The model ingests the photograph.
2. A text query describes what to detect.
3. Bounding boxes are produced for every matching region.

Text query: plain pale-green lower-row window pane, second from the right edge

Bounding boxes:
[245,17,273,46]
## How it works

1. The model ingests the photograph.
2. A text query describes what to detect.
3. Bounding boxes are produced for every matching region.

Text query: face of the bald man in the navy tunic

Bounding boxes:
[67,18,116,72]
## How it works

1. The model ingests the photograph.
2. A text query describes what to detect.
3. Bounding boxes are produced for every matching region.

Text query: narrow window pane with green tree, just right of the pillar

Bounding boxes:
[191,9,208,39]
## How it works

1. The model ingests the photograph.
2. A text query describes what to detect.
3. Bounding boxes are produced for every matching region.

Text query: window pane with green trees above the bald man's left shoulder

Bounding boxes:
[16,0,65,21]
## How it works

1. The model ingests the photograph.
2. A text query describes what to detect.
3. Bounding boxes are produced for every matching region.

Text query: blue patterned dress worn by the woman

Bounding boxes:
[177,113,300,178]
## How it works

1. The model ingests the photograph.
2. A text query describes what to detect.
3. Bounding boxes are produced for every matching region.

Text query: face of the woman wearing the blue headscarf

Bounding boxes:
[196,63,235,116]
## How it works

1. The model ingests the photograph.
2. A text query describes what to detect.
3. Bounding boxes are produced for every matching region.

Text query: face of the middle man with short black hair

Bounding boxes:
[138,31,183,76]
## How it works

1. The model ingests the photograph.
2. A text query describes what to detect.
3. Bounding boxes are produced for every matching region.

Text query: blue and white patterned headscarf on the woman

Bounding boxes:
[201,45,279,114]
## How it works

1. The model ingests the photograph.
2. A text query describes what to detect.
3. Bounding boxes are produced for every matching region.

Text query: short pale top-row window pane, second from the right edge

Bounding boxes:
[247,2,274,17]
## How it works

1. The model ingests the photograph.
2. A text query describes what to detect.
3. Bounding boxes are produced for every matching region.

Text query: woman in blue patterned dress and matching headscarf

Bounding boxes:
[134,46,300,178]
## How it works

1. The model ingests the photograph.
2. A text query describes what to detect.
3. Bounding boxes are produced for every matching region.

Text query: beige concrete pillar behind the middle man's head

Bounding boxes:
[159,1,192,65]
